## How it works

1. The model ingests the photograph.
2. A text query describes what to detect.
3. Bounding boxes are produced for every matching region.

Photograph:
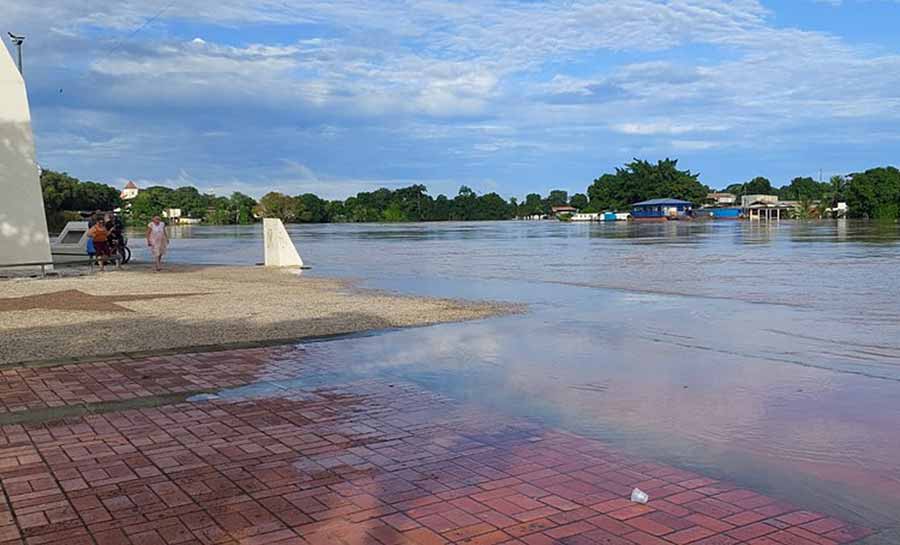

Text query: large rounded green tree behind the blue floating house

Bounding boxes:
[588,159,709,211]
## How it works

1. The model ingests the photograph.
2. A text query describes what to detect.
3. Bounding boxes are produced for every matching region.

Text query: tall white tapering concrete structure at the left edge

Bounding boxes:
[0,47,51,267]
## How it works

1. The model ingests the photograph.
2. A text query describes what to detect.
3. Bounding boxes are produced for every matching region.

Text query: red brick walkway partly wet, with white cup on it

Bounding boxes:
[0,348,871,545]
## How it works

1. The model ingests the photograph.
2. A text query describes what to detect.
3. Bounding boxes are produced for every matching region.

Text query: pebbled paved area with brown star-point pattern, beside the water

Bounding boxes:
[0,266,521,365]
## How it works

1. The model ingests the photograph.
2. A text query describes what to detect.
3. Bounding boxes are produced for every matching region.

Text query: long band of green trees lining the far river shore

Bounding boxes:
[41,159,900,230]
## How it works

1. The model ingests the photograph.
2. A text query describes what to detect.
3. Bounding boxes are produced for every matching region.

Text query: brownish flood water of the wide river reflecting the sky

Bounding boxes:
[132,220,900,528]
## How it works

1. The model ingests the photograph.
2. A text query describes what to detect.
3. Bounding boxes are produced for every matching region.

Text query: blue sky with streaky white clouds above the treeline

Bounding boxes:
[0,0,900,199]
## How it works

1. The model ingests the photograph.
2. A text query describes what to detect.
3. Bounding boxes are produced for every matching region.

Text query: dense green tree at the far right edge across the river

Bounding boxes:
[845,167,900,220]
